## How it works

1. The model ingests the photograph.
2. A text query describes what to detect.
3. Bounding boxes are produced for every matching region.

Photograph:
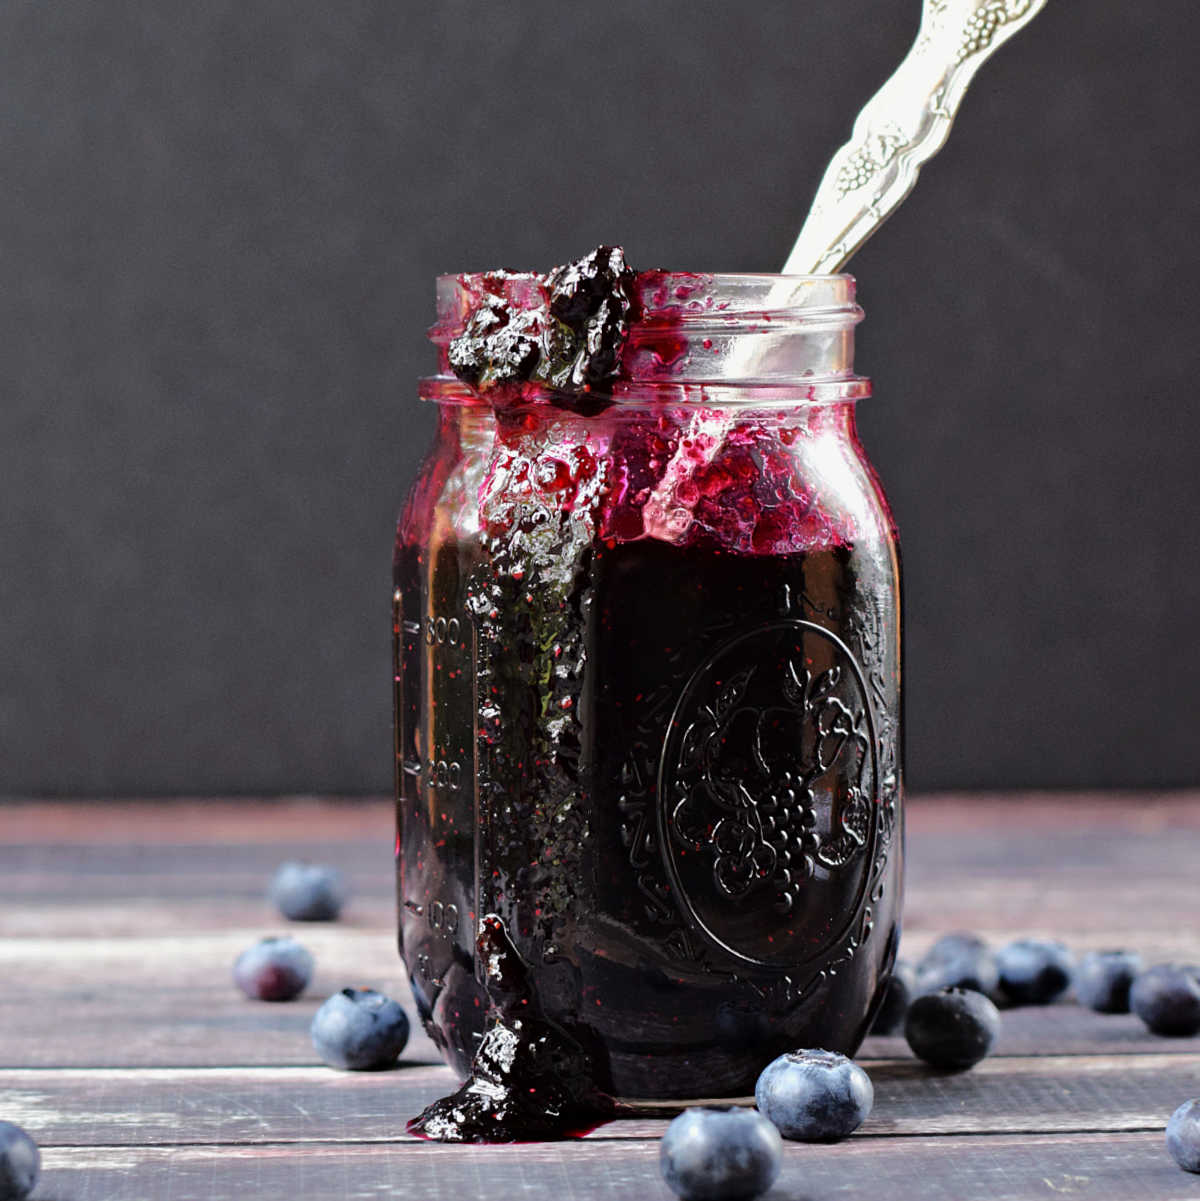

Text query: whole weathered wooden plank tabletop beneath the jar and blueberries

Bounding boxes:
[0,794,1200,1201]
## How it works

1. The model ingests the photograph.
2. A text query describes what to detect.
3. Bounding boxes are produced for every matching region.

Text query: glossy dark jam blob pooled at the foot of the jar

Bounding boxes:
[408,914,614,1142]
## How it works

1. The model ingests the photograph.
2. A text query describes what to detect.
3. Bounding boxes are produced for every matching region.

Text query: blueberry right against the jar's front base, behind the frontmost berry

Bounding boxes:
[754,1051,874,1142]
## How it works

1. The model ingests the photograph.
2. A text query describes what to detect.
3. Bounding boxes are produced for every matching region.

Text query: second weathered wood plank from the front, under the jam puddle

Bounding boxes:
[0,1050,1200,1146]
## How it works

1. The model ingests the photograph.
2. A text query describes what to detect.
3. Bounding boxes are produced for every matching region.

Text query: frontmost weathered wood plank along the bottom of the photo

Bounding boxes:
[30,1133,1196,1201]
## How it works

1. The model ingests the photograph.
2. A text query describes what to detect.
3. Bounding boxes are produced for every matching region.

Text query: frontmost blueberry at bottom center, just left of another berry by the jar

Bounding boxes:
[658,1105,783,1201]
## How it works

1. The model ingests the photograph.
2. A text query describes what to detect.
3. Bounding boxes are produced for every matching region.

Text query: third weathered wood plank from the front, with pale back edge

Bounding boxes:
[0,924,1200,1068]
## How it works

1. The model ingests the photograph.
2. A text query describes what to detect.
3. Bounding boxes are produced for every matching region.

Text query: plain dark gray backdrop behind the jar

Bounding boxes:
[0,0,1200,795]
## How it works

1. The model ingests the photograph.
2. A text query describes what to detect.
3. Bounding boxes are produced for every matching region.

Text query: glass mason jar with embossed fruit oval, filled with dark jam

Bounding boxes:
[394,273,903,1099]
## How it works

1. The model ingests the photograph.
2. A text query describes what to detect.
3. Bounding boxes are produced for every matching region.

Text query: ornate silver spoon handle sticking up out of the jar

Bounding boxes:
[783,0,1046,275]
